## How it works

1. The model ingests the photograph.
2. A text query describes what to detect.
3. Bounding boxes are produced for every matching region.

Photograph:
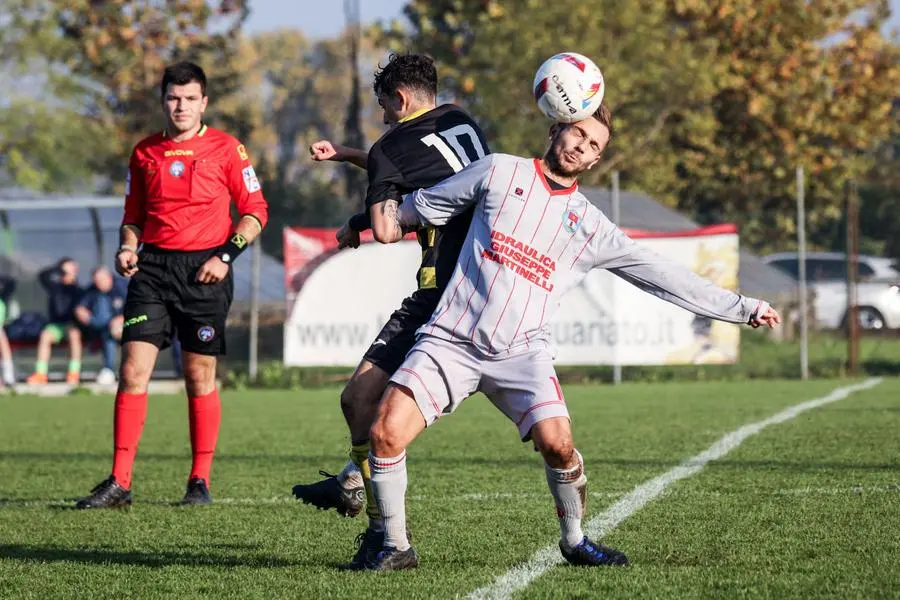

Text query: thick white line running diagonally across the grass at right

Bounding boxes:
[468,378,882,600]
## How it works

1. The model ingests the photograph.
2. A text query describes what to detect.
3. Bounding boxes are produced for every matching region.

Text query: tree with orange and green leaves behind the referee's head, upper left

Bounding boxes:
[0,0,247,191]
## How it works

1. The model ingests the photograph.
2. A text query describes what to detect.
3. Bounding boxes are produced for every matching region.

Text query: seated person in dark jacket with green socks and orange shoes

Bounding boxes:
[26,258,82,385]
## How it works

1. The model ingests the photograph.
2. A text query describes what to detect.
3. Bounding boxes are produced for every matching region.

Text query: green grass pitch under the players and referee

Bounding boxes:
[0,380,900,599]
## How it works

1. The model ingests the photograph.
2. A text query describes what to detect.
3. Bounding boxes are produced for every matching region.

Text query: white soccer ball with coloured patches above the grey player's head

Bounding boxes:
[534,52,605,123]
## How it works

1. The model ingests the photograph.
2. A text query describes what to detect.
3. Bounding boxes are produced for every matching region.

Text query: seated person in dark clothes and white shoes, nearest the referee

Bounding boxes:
[75,267,125,383]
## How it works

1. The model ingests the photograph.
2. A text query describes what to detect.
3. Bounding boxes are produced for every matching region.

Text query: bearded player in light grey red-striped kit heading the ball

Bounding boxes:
[360,107,781,571]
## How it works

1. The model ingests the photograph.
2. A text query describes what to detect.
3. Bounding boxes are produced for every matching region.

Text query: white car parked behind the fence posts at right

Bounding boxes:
[763,252,900,329]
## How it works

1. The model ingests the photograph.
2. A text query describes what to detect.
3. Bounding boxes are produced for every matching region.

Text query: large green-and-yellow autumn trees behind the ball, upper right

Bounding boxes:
[383,0,900,250]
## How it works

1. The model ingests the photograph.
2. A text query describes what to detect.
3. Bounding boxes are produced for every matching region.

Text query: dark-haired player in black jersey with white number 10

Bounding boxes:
[293,54,488,569]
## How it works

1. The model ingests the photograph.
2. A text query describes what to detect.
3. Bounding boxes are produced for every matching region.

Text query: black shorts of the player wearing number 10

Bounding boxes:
[363,289,441,374]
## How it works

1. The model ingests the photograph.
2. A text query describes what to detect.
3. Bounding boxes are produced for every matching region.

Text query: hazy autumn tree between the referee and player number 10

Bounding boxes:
[215,30,383,256]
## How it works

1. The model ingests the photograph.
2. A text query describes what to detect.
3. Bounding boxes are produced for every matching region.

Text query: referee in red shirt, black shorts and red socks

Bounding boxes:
[76,62,268,508]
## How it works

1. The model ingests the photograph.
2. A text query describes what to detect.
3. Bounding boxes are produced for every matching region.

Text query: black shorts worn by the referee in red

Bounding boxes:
[122,245,234,356]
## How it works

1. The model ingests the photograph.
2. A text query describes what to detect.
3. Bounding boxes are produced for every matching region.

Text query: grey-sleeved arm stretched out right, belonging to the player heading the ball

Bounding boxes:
[594,220,781,327]
